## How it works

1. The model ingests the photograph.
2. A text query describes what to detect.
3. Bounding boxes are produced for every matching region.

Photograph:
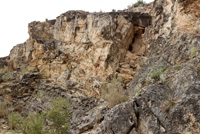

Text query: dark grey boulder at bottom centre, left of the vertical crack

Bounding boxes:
[84,101,138,134]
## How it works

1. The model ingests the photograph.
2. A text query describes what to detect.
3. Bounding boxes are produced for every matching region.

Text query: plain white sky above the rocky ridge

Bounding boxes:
[0,0,153,57]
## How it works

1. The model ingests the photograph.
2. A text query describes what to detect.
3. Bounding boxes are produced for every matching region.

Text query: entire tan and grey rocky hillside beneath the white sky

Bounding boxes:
[0,0,200,134]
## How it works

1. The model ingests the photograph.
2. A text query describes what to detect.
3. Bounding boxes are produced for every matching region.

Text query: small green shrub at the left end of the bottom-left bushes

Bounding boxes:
[8,113,22,129]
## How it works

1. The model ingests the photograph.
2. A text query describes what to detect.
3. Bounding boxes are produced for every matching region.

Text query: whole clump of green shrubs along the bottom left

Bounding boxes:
[8,98,71,134]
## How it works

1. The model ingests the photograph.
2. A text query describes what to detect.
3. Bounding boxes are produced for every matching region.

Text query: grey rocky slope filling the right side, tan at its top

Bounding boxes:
[129,0,200,134]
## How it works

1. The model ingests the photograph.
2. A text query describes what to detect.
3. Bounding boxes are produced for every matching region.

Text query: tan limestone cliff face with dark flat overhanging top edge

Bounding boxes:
[10,11,151,95]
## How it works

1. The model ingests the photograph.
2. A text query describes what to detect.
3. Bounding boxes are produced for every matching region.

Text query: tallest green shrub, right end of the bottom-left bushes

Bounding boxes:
[47,99,71,134]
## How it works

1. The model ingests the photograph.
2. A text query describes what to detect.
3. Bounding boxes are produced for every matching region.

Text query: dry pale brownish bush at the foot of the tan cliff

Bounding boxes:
[102,79,128,107]
